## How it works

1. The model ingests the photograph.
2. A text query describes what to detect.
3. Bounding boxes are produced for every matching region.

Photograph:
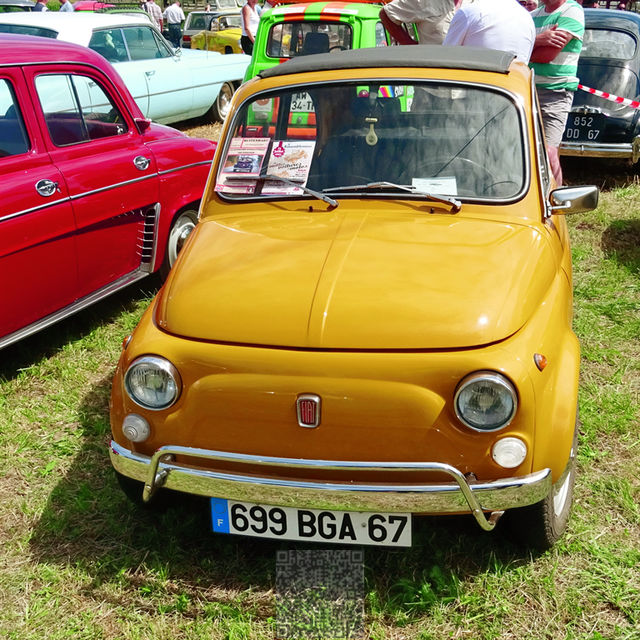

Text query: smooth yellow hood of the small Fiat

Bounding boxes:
[156,205,557,349]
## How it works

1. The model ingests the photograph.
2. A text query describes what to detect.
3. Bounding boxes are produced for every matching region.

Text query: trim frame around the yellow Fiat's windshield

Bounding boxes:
[215,76,531,205]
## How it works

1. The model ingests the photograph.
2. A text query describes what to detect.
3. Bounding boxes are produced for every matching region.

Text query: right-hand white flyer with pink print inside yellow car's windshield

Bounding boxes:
[262,140,316,195]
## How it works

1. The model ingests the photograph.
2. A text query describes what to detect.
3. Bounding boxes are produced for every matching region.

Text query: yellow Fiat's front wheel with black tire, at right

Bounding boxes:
[503,421,578,551]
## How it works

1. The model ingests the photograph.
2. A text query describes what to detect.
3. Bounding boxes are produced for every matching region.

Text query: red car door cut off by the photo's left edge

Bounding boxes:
[0,67,78,347]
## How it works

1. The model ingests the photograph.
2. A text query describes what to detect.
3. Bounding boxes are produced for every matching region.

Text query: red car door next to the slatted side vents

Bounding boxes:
[26,65,159,296]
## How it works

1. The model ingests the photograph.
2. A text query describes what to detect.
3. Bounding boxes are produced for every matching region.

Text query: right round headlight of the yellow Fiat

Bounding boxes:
[454,371,518,431]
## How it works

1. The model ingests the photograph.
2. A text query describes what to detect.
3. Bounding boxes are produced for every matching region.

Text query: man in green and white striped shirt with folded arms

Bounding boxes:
[529,0,584,186]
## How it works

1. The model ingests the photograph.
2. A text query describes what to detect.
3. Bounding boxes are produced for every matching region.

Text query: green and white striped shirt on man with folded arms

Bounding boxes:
[529,0,584,91]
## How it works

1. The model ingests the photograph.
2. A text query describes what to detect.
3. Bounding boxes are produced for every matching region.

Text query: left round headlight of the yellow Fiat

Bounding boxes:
[124,356,182,410]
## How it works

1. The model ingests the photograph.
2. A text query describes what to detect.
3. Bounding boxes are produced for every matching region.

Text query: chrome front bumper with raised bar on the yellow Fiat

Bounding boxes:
[110,441,551,531]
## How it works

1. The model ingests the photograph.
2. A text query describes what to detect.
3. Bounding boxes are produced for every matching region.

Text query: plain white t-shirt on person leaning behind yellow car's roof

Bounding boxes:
[444,0,536,64]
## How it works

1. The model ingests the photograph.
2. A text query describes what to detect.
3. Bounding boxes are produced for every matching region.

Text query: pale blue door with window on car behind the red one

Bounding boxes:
[115,26,194,122]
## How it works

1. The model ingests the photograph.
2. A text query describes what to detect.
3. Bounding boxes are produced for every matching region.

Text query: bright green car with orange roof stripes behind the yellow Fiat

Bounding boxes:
[244,2,390,81]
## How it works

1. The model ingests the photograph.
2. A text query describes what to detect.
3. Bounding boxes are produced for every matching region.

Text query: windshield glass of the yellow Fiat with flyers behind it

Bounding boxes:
[216,82,527,200]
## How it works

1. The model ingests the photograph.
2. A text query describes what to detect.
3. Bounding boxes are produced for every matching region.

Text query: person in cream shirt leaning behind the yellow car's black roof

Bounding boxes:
[380,0,461,44]
